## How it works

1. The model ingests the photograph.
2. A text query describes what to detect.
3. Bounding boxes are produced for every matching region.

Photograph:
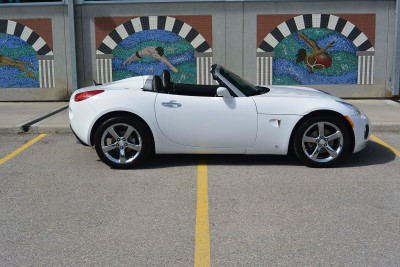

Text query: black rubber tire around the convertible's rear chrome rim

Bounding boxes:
[94,117,152,169]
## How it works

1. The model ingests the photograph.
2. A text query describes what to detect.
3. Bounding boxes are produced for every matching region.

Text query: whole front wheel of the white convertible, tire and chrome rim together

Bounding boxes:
[294,115,351,168]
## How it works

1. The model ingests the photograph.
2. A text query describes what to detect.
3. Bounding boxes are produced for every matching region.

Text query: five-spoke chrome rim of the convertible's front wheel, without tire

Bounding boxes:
[302,121,344,163]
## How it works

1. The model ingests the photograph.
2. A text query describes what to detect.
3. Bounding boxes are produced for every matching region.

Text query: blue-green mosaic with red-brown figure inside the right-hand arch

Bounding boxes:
[272,28,358,84]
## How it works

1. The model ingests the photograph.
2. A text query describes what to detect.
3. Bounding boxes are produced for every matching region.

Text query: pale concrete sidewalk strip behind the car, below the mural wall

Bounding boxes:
[0,99,400,133]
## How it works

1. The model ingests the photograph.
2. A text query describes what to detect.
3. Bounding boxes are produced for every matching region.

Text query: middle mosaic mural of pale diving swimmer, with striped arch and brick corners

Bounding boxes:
[95,15,212,84]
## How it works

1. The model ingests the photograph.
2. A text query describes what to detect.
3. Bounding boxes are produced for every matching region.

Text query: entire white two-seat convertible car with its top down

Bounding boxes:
[69,65,371,168]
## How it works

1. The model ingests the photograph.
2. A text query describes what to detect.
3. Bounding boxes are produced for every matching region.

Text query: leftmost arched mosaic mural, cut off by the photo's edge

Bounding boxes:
[0,19,55,88]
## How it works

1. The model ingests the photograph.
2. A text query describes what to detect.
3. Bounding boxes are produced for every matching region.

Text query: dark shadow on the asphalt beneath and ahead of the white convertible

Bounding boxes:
[140,141,396,169]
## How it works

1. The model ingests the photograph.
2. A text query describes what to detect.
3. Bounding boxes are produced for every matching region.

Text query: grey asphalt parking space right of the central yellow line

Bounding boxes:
[209,142,400,266]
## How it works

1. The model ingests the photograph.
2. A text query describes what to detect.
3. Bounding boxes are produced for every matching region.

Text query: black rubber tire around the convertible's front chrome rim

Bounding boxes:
[294,115,351,168]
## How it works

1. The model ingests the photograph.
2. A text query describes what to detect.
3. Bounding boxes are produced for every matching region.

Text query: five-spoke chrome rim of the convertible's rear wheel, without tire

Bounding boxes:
[101,123,142,164]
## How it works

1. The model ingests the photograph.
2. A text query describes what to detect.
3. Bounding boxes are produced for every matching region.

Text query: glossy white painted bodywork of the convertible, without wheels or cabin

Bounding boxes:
[69,68,371,162]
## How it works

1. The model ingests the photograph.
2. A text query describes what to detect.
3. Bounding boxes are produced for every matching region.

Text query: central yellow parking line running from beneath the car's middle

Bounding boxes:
[194,160,210,267]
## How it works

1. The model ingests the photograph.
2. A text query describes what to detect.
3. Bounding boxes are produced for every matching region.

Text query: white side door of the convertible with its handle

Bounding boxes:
[155,94,257,149]
